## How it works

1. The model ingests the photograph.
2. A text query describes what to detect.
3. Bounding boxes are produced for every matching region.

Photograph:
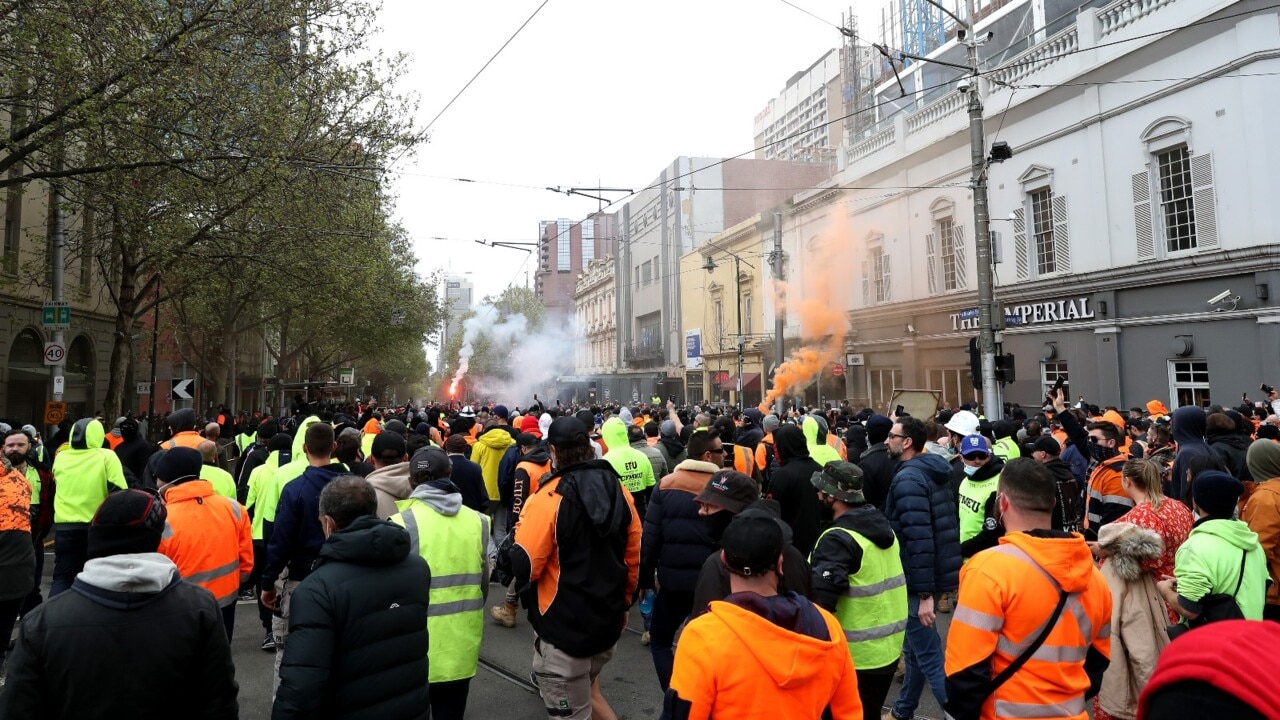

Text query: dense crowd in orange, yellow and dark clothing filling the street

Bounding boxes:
[0,392,1280,720]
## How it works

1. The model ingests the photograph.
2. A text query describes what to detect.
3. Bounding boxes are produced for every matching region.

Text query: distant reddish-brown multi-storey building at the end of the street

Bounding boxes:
[534,213,614,318]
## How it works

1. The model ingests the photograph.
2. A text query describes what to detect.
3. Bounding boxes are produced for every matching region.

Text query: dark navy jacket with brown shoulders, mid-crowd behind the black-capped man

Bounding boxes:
[640,460,719,593]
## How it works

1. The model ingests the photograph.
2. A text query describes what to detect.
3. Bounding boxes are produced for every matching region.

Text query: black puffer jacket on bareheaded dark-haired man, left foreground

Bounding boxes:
[271,515,431,720]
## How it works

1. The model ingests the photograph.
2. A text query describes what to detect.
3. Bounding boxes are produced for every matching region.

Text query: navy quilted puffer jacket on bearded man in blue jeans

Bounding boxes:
[884,454,963,594]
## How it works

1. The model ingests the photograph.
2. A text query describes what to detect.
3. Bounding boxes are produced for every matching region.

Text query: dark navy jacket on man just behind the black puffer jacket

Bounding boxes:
[262,465,348,587]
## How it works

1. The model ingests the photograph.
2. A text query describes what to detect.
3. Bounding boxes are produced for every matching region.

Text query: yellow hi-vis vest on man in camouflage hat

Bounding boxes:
[819,520,906,670]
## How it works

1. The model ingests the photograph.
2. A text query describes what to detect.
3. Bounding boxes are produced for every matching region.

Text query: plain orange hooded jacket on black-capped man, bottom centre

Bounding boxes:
[667,601,863,720]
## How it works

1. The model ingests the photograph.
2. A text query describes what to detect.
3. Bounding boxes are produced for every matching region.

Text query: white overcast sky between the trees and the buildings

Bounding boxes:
[371,0,882,299]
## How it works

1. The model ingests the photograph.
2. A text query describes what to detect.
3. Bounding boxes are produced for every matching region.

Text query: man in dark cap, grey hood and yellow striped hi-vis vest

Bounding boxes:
[390,447,489,720]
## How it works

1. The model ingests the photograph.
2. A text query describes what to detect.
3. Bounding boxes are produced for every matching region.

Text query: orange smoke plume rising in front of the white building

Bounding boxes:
[759,215,856,414]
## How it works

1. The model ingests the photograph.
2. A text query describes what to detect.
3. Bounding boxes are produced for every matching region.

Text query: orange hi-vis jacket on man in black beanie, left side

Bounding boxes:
[159,480,253,607]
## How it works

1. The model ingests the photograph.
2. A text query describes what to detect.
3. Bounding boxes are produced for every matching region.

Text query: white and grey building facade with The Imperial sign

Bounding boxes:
[787,0,1280,409]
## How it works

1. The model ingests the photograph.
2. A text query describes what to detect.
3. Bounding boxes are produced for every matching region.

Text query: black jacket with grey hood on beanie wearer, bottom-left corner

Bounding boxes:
[0,552,239,720]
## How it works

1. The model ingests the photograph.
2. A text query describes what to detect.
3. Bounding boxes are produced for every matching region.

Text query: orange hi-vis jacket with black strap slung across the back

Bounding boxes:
[946,530,1111,720]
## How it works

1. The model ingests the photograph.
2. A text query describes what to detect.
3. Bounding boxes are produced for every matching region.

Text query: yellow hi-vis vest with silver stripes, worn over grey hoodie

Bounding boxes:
[390,498,489,683]
